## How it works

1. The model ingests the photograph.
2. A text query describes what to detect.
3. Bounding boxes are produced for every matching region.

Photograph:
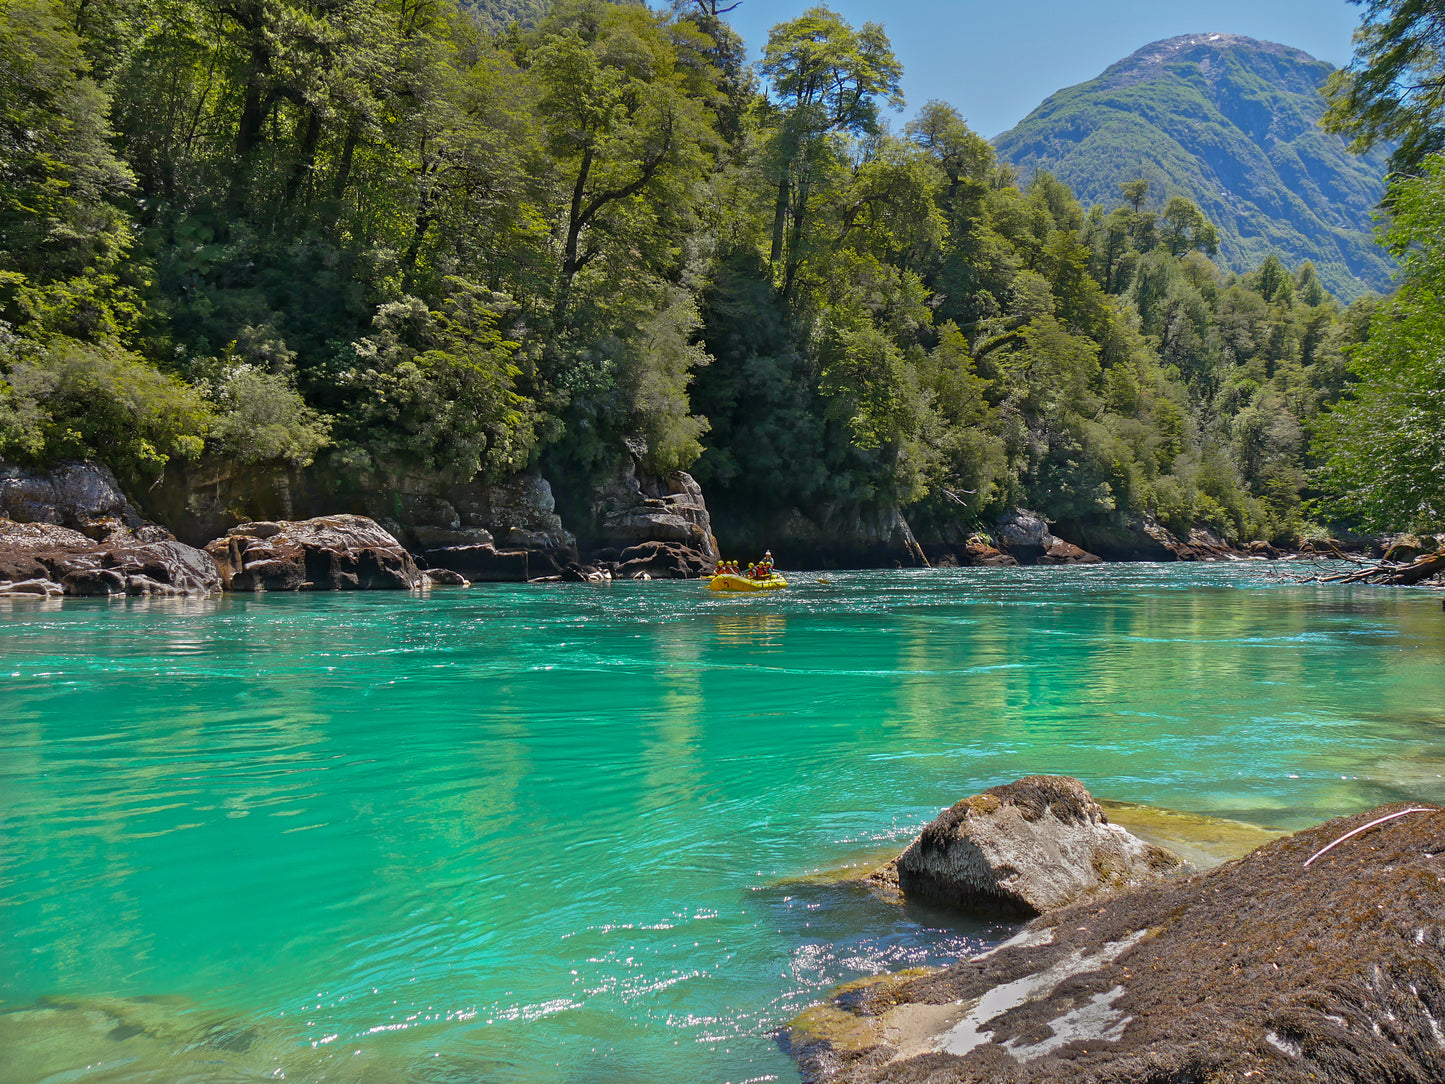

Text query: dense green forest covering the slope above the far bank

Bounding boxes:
[0,0,1445,539]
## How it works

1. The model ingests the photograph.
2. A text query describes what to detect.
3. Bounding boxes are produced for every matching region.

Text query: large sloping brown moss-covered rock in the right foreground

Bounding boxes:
[790,802,1445,1084]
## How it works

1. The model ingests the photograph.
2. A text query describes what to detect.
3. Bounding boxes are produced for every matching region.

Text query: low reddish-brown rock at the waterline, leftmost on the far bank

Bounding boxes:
[0,519,221,597]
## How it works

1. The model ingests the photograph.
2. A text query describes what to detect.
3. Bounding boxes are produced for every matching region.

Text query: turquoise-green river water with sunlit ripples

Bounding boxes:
[0,564,1445,1084]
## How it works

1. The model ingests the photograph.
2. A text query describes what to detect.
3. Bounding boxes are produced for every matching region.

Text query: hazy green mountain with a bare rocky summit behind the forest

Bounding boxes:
[994,33,1393,299]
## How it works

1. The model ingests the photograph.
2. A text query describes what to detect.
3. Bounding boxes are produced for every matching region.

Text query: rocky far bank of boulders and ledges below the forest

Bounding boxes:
[0,457,1439,595]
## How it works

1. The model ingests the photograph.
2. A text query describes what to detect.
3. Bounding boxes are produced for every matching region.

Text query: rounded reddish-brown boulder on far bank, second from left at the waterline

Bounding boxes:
[205,516,422,591]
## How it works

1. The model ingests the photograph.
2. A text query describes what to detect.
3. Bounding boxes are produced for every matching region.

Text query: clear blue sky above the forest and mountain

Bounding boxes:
[727,0,1360,137]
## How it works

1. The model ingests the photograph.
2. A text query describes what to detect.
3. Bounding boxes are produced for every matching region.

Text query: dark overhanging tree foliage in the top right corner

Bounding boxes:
[1321,0,1445,173]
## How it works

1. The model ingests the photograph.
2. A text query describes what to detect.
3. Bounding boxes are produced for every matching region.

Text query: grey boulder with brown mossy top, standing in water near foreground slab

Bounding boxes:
[893,775,1182,918]
